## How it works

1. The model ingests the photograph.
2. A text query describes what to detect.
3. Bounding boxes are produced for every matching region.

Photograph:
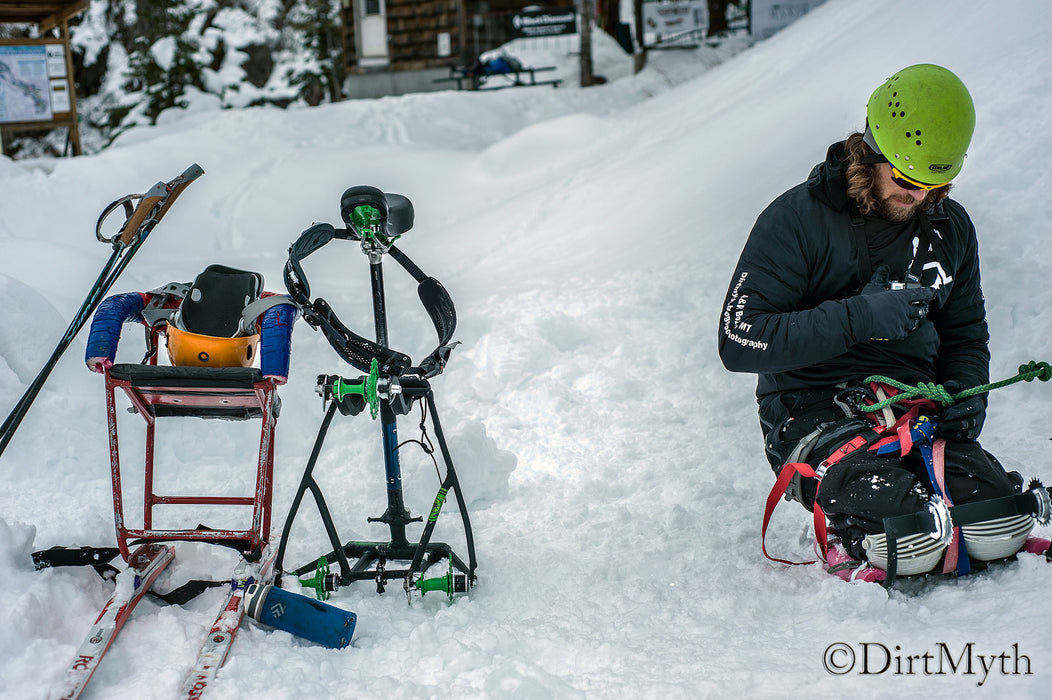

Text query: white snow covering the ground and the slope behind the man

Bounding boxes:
[0,0,1052,699]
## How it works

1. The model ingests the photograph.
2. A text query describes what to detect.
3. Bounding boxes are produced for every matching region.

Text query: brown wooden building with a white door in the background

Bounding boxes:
[341,0,574,98]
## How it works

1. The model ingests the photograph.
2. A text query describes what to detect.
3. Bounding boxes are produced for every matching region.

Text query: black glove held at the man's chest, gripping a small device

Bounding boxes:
[848,265,935,340]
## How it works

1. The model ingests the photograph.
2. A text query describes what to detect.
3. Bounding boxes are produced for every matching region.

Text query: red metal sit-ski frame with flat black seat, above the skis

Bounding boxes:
[105,356,277,561]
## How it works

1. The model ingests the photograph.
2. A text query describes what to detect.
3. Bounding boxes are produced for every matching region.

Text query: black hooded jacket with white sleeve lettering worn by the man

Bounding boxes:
[719,142,990,421]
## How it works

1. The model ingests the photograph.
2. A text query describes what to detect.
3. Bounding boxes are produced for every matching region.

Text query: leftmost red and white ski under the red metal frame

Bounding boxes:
[52,544,176,700]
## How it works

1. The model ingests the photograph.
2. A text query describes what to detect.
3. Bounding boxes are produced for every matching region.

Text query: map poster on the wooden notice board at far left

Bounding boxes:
[0,40,73,124]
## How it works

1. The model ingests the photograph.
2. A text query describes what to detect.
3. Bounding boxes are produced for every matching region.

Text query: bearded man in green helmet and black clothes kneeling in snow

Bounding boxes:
[719,64,1032,575]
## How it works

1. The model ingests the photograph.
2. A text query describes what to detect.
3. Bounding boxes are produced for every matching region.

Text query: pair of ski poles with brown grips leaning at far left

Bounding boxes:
[0,163,204,455]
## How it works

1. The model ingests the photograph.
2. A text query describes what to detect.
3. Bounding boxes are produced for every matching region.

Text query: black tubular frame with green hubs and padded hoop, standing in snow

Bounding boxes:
[276,185,477,600]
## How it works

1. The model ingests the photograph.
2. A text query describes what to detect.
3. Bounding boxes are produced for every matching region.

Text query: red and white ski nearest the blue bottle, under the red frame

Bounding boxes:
[183,545,278,700]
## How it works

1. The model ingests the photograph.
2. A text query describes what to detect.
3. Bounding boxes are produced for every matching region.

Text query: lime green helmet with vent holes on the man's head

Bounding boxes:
[866,63,975,185]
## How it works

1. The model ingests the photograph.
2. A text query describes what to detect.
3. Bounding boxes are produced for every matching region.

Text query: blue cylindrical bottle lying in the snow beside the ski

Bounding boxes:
[244,583,358,649]
